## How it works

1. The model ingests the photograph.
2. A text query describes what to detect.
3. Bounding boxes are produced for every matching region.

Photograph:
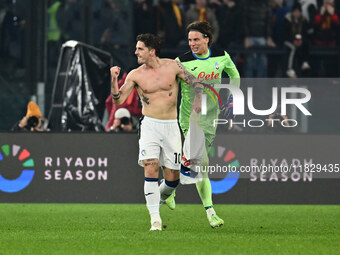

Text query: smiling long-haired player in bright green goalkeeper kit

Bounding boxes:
[166,21,240,228]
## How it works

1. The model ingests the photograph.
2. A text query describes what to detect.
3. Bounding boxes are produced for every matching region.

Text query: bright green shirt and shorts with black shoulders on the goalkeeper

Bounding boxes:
[176,49,240,143]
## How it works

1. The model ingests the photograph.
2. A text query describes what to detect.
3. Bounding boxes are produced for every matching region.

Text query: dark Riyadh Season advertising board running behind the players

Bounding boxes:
[0,133,340,204]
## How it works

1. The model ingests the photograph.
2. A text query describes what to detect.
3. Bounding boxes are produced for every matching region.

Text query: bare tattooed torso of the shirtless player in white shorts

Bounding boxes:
[132,59,178,120]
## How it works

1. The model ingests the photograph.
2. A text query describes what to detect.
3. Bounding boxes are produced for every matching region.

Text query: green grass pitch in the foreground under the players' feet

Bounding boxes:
[0,204,340,255]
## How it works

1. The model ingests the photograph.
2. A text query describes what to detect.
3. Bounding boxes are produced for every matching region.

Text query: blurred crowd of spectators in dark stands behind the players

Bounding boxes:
[0,0,340,78]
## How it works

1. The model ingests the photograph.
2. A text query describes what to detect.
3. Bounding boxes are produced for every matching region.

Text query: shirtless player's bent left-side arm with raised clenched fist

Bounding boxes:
[110,66,136,105]
